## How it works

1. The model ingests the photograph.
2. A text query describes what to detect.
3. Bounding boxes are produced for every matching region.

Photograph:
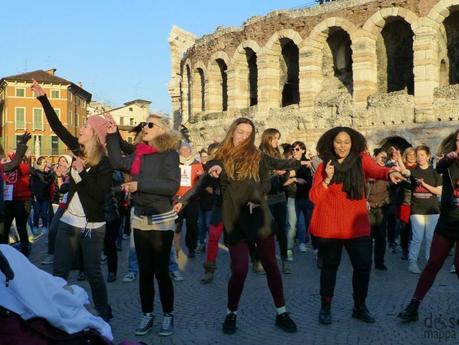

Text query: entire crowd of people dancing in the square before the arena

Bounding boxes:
[0,82,459,342]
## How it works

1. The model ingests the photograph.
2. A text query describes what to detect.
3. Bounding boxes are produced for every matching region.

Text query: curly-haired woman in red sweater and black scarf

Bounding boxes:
[310,127,403,325]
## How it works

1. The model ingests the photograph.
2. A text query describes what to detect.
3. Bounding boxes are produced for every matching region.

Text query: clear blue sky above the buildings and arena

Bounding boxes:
[0,0,320,112]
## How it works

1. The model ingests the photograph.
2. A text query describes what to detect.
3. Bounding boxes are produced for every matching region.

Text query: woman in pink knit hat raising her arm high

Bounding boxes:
[32,80,113,320]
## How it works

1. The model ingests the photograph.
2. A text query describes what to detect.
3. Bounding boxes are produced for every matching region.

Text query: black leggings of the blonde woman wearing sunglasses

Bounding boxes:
[134,229,174,313]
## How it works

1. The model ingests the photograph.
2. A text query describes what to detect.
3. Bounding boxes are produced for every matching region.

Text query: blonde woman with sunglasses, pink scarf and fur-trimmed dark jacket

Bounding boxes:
[107,115,180,336]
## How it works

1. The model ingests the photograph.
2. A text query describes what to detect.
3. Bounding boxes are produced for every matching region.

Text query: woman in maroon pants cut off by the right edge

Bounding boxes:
[398,130,459,322]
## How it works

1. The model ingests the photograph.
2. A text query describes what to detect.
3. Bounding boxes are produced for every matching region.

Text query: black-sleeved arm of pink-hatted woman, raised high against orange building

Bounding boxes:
[32,79,80,155]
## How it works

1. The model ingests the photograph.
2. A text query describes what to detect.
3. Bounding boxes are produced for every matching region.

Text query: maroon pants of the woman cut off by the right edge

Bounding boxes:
[414,233,459,300]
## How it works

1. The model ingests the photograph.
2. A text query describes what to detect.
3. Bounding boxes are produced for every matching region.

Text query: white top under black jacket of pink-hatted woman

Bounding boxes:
[60,168,105,229]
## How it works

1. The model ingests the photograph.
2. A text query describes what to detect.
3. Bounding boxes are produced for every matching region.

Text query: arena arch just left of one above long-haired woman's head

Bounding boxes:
[206,51,230,111]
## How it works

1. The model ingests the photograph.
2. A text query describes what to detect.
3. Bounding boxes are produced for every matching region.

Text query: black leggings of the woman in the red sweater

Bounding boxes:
[317,237,372,305]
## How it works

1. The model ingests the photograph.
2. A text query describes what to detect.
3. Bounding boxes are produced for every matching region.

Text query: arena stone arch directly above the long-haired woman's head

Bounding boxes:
[229,40,261,109]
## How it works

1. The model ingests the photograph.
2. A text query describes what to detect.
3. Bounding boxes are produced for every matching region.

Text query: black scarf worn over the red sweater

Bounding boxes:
[324,152,365,200]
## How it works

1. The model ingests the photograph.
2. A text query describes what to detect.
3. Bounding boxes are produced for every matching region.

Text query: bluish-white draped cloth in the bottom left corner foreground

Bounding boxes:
[0,244,113,340]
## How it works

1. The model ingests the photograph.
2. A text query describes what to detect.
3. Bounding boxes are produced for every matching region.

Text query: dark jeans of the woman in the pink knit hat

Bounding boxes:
[53,221,109,314]
